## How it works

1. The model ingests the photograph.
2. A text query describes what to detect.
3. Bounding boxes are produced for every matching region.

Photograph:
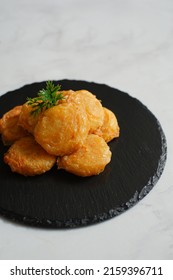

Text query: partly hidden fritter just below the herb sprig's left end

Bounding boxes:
[19,102,39,134]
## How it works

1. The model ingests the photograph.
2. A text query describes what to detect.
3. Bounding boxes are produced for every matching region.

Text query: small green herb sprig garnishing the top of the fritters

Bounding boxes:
[27,81,64,116]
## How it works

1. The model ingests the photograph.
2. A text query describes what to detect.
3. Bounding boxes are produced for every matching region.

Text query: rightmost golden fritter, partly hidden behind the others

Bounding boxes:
[94,107,120,142]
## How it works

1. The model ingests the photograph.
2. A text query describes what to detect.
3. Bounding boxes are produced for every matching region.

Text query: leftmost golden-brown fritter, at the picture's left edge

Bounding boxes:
[0,106,28,145]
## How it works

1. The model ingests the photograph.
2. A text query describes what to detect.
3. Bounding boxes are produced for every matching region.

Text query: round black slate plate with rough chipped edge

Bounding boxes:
[0,80,166,228]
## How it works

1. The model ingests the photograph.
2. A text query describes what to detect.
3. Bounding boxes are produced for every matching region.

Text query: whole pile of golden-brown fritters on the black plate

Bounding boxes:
[0,90,120,177]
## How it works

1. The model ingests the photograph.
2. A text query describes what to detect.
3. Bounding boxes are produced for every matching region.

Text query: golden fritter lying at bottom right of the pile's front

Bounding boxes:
[58,134,111,177]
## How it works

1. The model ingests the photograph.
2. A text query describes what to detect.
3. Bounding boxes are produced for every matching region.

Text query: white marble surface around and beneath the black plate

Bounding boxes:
[0,0,173,259]
